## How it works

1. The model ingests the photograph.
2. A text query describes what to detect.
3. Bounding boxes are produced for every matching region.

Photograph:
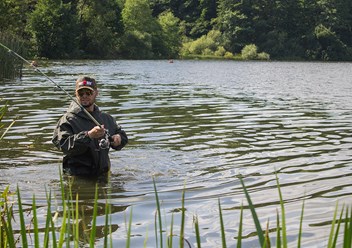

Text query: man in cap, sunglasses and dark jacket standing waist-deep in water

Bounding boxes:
[52,77,128,176]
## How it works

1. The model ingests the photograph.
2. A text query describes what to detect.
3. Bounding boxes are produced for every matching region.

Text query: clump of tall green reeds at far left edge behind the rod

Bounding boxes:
[0,32,26,81]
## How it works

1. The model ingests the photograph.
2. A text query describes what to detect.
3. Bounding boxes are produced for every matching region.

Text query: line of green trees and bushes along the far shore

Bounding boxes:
[0,0,352,61]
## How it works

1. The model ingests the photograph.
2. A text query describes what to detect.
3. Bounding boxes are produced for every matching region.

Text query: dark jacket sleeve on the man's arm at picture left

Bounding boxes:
[52,117,92,155]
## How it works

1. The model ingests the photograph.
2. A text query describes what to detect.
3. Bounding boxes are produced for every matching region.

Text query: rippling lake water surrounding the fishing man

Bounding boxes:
[0,60,352,247]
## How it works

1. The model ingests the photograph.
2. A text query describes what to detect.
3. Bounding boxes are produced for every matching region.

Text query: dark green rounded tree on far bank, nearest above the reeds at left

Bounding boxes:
[28,0,78,58]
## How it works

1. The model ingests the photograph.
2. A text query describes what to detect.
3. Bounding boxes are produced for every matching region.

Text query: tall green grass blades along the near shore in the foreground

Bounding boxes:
[0,174,352,248]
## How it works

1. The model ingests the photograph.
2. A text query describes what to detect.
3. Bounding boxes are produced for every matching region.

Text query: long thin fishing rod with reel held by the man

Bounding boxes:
[0,42,111,149]
